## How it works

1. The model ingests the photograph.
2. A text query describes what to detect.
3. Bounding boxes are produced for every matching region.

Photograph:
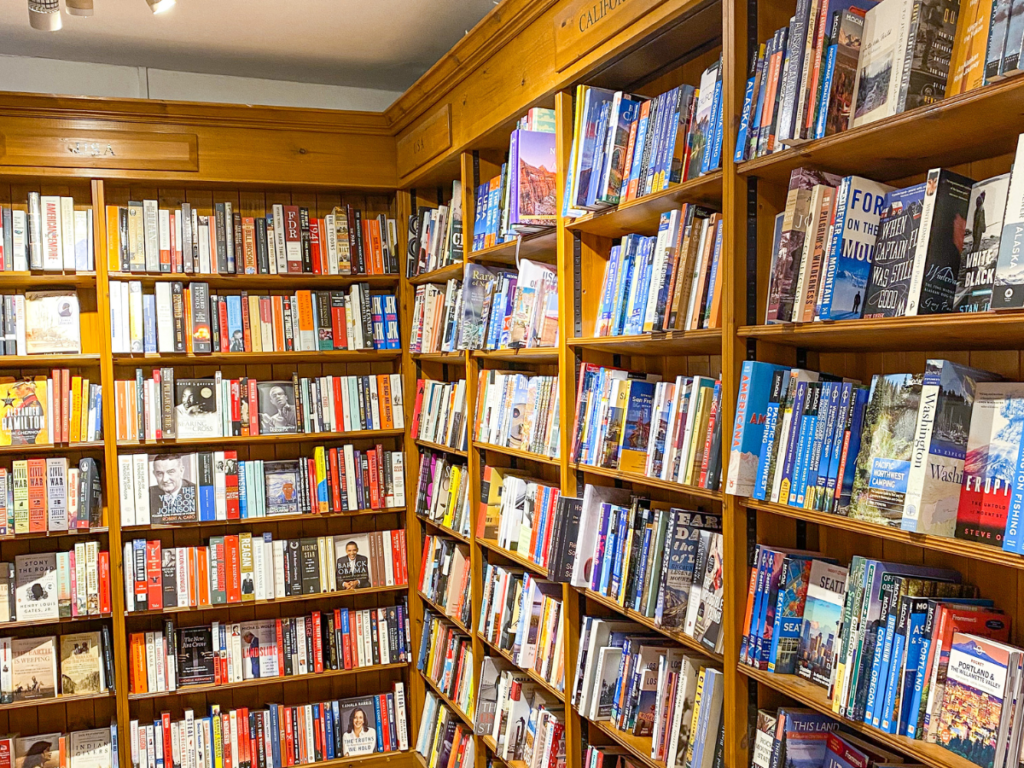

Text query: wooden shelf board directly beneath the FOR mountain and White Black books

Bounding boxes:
[738,310,1024,352]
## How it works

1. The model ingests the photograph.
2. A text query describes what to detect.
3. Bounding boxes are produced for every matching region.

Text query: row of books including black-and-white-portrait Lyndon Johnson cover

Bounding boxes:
[118,445,406,527]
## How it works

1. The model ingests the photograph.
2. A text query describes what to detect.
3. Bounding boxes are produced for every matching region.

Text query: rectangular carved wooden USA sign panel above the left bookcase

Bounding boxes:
[0,126,199,171]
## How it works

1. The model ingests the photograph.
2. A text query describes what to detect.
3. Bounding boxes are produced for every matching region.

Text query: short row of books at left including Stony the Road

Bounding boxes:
[8,541,111,623]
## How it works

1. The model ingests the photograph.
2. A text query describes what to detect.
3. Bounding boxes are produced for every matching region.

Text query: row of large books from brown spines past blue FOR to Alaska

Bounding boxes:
[765,135,1024,324]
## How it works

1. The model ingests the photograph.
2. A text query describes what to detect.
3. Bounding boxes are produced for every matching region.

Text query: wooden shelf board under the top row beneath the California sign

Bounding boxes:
[565,171,723,238]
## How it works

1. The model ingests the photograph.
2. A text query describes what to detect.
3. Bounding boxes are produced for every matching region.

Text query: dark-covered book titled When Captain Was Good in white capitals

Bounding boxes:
[864,183,925,317]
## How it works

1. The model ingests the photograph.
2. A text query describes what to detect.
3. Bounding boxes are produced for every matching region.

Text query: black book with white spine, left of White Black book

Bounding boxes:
[906,168,974,315]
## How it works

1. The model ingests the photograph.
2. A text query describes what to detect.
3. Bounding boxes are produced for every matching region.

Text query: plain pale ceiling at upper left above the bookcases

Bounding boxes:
[0,0,495,90]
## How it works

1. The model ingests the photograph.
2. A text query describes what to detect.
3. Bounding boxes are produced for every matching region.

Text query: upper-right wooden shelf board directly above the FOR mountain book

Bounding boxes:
[738,77,1024,184]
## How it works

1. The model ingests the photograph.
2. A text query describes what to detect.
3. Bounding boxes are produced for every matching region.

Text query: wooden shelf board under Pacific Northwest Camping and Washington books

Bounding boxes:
[740,499,1024,569]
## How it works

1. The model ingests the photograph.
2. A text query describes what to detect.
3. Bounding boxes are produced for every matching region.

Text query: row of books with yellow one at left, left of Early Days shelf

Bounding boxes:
[477,465,561,568]
